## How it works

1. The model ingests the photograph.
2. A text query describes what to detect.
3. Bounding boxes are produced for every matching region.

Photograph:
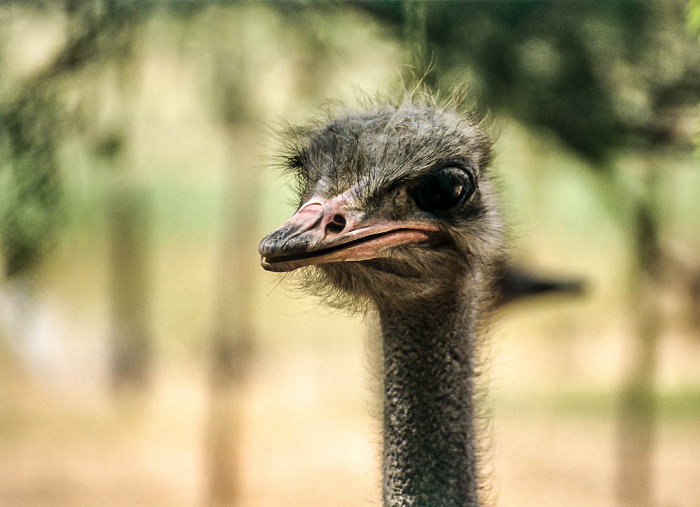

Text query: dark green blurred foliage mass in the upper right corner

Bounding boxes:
[354,0,700,161]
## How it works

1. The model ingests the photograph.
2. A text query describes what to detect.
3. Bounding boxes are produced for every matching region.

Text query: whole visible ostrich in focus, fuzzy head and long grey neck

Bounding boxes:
[259,93,503,507]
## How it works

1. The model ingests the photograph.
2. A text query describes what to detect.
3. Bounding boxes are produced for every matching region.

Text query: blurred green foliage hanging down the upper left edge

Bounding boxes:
[0,2,139,276]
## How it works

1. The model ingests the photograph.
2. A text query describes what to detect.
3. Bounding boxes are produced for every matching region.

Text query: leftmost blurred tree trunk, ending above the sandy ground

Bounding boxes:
[105,13,153,395]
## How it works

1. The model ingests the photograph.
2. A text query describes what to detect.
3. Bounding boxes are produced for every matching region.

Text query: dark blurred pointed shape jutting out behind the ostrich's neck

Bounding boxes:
[495,264,585,305]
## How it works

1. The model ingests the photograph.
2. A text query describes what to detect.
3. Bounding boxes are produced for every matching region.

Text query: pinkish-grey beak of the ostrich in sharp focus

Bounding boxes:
[258,194,438,271]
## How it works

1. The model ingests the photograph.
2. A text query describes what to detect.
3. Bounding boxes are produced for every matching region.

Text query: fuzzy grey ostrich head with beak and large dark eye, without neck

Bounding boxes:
[259,98,501,305]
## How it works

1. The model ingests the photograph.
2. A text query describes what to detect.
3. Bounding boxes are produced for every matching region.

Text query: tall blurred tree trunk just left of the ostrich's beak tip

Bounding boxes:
[206,11,260,507]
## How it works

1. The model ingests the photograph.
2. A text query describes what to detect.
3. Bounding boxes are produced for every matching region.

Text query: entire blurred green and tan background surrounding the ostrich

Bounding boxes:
[0,0,700,507]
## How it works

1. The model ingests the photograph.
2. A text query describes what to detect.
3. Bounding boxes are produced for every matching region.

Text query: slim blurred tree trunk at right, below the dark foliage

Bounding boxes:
[617,162,661,507]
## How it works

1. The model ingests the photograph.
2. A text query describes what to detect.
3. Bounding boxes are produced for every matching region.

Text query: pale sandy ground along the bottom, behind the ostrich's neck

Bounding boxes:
[0,347,700,507]
